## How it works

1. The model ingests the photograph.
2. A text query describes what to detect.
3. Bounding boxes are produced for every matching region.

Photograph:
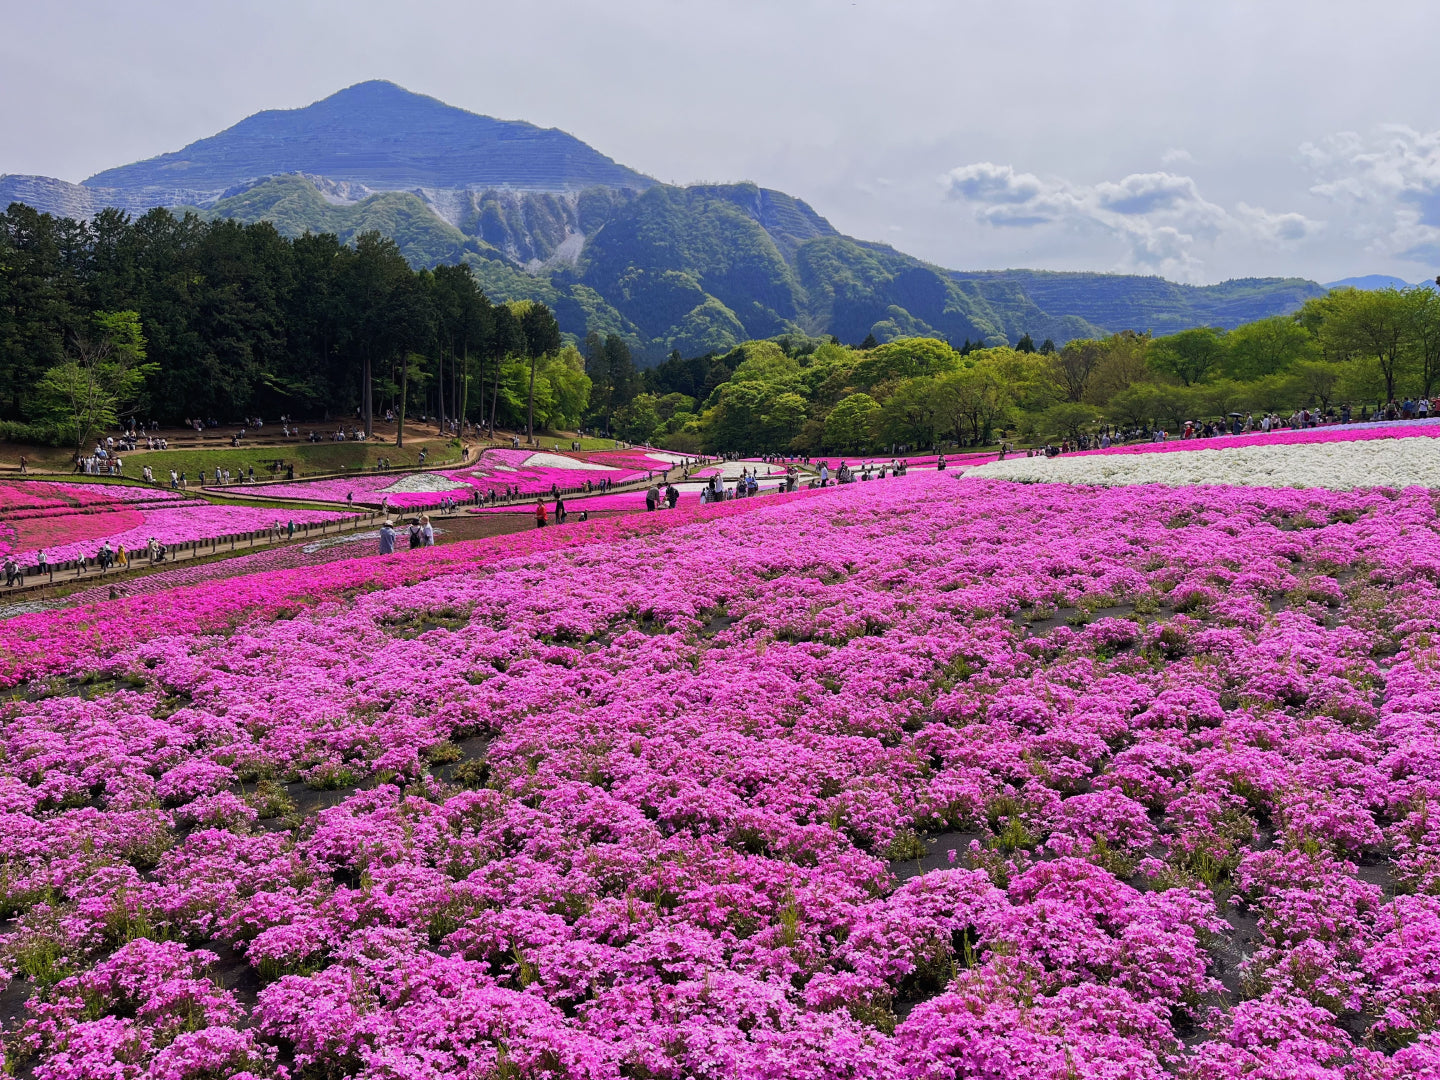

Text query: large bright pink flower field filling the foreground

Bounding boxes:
[0,474,1440,1080]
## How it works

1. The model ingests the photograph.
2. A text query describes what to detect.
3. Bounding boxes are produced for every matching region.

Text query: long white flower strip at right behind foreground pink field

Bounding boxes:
[963,436,1440,491]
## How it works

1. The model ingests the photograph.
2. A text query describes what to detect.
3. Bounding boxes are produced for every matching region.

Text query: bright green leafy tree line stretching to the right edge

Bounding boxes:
[612,287,1440,454]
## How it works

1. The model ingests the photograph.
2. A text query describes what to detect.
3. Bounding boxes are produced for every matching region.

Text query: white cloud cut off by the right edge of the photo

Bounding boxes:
[1300,125,1440,265]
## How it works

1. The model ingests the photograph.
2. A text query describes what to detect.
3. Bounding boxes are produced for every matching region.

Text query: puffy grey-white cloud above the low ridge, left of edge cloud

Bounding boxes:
[942,161,1320,279]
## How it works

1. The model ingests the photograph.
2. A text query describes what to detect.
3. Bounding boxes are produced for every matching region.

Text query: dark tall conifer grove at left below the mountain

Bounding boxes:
[0,203,573,436]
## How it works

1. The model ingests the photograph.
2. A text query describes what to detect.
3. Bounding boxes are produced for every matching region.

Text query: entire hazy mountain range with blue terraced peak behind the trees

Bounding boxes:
[0,82,1325,361]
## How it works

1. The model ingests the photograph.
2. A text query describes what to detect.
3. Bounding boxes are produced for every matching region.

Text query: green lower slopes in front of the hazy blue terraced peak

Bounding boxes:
[199,176,1323,364]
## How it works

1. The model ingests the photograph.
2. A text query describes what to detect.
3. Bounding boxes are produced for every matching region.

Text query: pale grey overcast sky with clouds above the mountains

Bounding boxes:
[0,0,1440,282]
